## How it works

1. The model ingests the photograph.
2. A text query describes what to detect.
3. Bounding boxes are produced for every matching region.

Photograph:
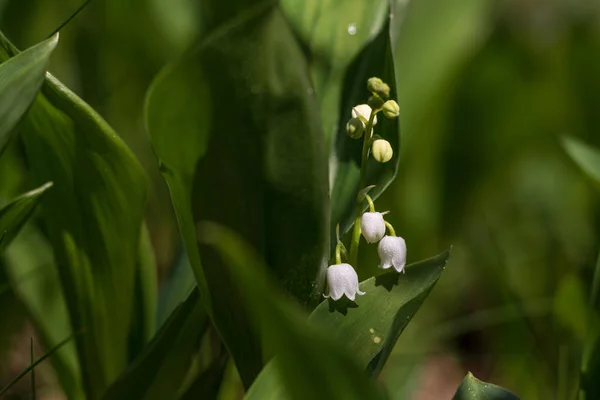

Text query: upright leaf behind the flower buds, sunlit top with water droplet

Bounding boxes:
[281,0,400,236]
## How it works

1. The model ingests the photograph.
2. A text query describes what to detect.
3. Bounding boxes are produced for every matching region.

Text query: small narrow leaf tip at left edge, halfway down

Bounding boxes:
[0,182,52,252]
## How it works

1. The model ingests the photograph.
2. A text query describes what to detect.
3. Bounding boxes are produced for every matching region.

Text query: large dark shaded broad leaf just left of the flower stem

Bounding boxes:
[146,2,329,386]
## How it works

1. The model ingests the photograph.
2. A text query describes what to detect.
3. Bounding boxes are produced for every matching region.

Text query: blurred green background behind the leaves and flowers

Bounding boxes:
[0,0,600,399]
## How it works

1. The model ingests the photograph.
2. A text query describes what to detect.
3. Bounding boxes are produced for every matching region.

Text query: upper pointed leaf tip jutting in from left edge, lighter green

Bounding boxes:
[0,34,58,154]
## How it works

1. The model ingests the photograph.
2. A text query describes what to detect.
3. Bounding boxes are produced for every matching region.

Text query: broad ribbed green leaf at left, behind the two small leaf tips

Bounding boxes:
[0,32,146,400]
